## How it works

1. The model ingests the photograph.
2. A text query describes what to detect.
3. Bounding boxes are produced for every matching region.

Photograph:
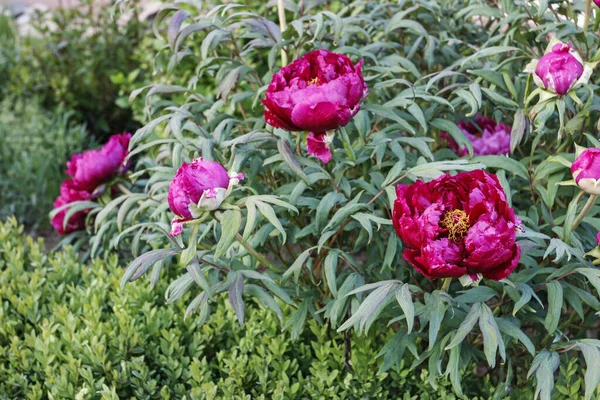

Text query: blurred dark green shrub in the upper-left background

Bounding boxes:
[3,0,149,141]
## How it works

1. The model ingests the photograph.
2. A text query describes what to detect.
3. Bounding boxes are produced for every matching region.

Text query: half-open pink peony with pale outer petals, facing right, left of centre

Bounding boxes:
[168,158,244,236]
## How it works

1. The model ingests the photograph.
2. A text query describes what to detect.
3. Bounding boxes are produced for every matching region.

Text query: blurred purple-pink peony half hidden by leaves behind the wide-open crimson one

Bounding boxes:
[442,115,511,157]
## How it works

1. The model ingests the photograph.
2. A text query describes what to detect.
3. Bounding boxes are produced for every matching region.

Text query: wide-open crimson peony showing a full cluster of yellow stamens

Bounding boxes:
[392,170,521,281]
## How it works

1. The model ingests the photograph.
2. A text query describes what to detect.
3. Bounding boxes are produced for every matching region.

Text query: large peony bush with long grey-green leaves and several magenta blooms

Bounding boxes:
[52,0,600,399]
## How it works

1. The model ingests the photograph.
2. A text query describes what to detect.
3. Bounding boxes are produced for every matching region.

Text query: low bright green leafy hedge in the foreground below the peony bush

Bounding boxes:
[0,219,510,400]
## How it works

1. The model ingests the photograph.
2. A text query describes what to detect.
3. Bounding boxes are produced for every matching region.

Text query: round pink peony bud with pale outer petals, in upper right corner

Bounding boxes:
[525,40,592,95]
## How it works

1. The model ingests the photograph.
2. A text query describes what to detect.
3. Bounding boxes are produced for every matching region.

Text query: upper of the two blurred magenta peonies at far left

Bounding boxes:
[67,133,131,192]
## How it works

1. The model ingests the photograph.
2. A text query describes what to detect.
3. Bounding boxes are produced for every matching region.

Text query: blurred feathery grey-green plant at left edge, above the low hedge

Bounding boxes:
[0,97,87,230]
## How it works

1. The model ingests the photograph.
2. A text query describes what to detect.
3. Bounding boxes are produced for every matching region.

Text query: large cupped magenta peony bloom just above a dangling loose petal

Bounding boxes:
[263,50,367,132]
